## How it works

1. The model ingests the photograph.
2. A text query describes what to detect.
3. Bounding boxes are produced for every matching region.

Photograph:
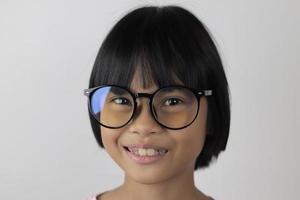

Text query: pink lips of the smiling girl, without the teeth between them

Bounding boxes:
[123,144,169,164]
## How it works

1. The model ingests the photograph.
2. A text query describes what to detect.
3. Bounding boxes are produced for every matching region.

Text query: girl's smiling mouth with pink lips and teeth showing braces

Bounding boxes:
[123,145,169,164]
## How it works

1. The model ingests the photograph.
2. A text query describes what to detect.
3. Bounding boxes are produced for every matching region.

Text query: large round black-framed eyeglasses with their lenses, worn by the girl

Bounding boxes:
[84,85,212,130]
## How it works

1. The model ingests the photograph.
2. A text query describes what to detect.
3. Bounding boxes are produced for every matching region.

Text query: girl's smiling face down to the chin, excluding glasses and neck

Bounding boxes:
[101,72,207,184]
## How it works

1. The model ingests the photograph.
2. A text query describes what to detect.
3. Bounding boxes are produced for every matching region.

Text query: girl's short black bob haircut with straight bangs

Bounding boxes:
[89,5,230,170]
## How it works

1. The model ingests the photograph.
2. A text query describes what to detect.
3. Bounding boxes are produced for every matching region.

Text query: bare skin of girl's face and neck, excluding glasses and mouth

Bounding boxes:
[98,75,210,200]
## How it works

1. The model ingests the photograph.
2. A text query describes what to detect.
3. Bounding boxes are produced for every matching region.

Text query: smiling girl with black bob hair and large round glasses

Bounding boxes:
[85,6,230,200]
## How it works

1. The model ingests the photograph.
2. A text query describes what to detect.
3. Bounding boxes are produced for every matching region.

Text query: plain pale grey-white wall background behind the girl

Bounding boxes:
[0,0,300,200]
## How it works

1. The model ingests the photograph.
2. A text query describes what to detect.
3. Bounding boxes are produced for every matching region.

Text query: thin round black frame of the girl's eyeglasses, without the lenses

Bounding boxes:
[83,85,212,130]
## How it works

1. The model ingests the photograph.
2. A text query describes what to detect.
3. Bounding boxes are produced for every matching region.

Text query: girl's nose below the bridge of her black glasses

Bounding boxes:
[129,98,162,135]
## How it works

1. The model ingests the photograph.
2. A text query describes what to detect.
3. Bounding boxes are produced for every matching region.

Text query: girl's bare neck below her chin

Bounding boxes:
[113,165,206,200]
